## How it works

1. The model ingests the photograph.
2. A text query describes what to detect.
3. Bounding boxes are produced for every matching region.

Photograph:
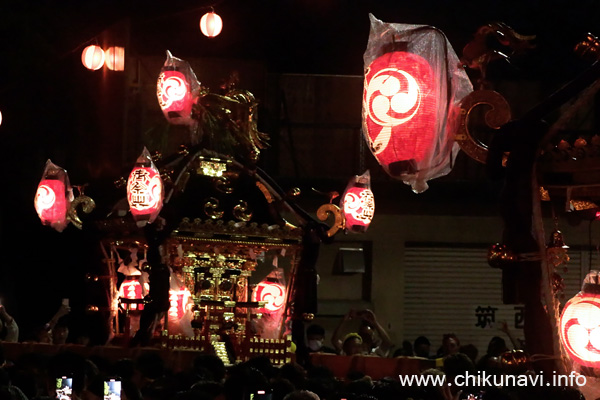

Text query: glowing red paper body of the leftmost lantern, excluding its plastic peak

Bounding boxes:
[34,179,69,231]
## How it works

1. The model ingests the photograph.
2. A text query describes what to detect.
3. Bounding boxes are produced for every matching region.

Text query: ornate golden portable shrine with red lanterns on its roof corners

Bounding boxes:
[30,48,342,365]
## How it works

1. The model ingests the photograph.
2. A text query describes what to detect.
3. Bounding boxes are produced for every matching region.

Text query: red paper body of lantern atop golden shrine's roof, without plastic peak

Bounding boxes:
[156,70,194,124]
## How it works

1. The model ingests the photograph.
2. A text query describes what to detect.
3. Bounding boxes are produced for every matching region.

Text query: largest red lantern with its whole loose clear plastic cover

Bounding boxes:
[362,15,473,193]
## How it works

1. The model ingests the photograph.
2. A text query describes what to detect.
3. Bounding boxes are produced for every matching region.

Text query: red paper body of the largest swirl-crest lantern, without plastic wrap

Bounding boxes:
[363,51,439,176]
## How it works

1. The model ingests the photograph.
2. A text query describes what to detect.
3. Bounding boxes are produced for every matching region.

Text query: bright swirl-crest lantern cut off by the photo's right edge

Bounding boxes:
[560,271,600,368]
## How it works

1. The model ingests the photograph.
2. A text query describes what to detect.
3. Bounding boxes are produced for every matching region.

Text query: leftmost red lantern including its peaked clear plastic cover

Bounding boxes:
[34,160,73,232]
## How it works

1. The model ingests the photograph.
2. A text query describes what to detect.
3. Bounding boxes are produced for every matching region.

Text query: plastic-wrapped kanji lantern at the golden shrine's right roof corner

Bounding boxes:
[342,170,375,233]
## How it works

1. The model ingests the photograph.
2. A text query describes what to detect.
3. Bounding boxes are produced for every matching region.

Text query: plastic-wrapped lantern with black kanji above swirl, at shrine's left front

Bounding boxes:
[127,147,163,227]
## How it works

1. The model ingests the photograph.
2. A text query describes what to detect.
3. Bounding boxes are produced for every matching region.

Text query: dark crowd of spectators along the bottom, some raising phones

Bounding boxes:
[0,303,583,400]
